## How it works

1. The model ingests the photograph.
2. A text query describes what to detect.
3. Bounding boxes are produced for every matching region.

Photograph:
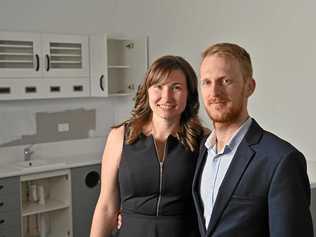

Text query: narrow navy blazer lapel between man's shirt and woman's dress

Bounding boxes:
[192,139,207,235]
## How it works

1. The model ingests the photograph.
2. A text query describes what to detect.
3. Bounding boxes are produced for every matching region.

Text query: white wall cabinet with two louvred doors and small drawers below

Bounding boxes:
[0,32,90,100]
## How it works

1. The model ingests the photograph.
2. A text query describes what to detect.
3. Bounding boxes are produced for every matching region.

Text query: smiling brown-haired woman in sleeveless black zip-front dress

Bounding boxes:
[90,56,203,237]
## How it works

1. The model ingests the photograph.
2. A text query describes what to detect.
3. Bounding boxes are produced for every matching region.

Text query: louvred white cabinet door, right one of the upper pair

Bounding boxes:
[41,34,89,79]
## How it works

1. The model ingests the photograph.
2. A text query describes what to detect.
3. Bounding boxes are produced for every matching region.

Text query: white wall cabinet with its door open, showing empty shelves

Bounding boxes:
[90,34,148,97]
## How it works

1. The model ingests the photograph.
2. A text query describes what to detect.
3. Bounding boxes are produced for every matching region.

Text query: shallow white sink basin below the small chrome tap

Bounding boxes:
[15,160,65,170]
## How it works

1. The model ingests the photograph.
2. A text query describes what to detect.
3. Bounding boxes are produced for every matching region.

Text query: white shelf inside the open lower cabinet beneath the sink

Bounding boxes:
[22,199,70,216]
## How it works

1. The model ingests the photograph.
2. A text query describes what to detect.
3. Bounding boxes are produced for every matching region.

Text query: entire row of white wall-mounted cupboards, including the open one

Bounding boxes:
[0,31,148,100]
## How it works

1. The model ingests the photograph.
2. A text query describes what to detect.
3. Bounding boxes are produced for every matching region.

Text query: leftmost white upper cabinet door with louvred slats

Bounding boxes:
[0,32,42,79]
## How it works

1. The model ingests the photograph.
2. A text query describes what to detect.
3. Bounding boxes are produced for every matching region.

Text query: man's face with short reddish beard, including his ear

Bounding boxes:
[200,54,255,123]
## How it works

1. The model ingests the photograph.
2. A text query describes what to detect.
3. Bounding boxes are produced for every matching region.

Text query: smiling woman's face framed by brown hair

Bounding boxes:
[148,70,188,120]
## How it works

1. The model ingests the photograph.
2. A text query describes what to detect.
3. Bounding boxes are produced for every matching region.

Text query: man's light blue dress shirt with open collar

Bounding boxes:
[200,117,252,229]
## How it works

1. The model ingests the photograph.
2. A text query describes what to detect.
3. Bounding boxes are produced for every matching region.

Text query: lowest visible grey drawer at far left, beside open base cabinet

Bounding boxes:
[0,211,21,233]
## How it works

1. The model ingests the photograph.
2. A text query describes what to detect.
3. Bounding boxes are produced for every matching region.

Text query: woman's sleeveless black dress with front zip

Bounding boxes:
[117,135,200,237]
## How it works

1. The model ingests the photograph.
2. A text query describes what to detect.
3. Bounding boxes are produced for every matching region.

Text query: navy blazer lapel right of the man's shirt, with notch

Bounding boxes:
[207,119,263,236]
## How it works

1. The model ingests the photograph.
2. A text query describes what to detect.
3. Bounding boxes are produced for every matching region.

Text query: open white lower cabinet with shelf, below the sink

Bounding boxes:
[21,170,73,237]
